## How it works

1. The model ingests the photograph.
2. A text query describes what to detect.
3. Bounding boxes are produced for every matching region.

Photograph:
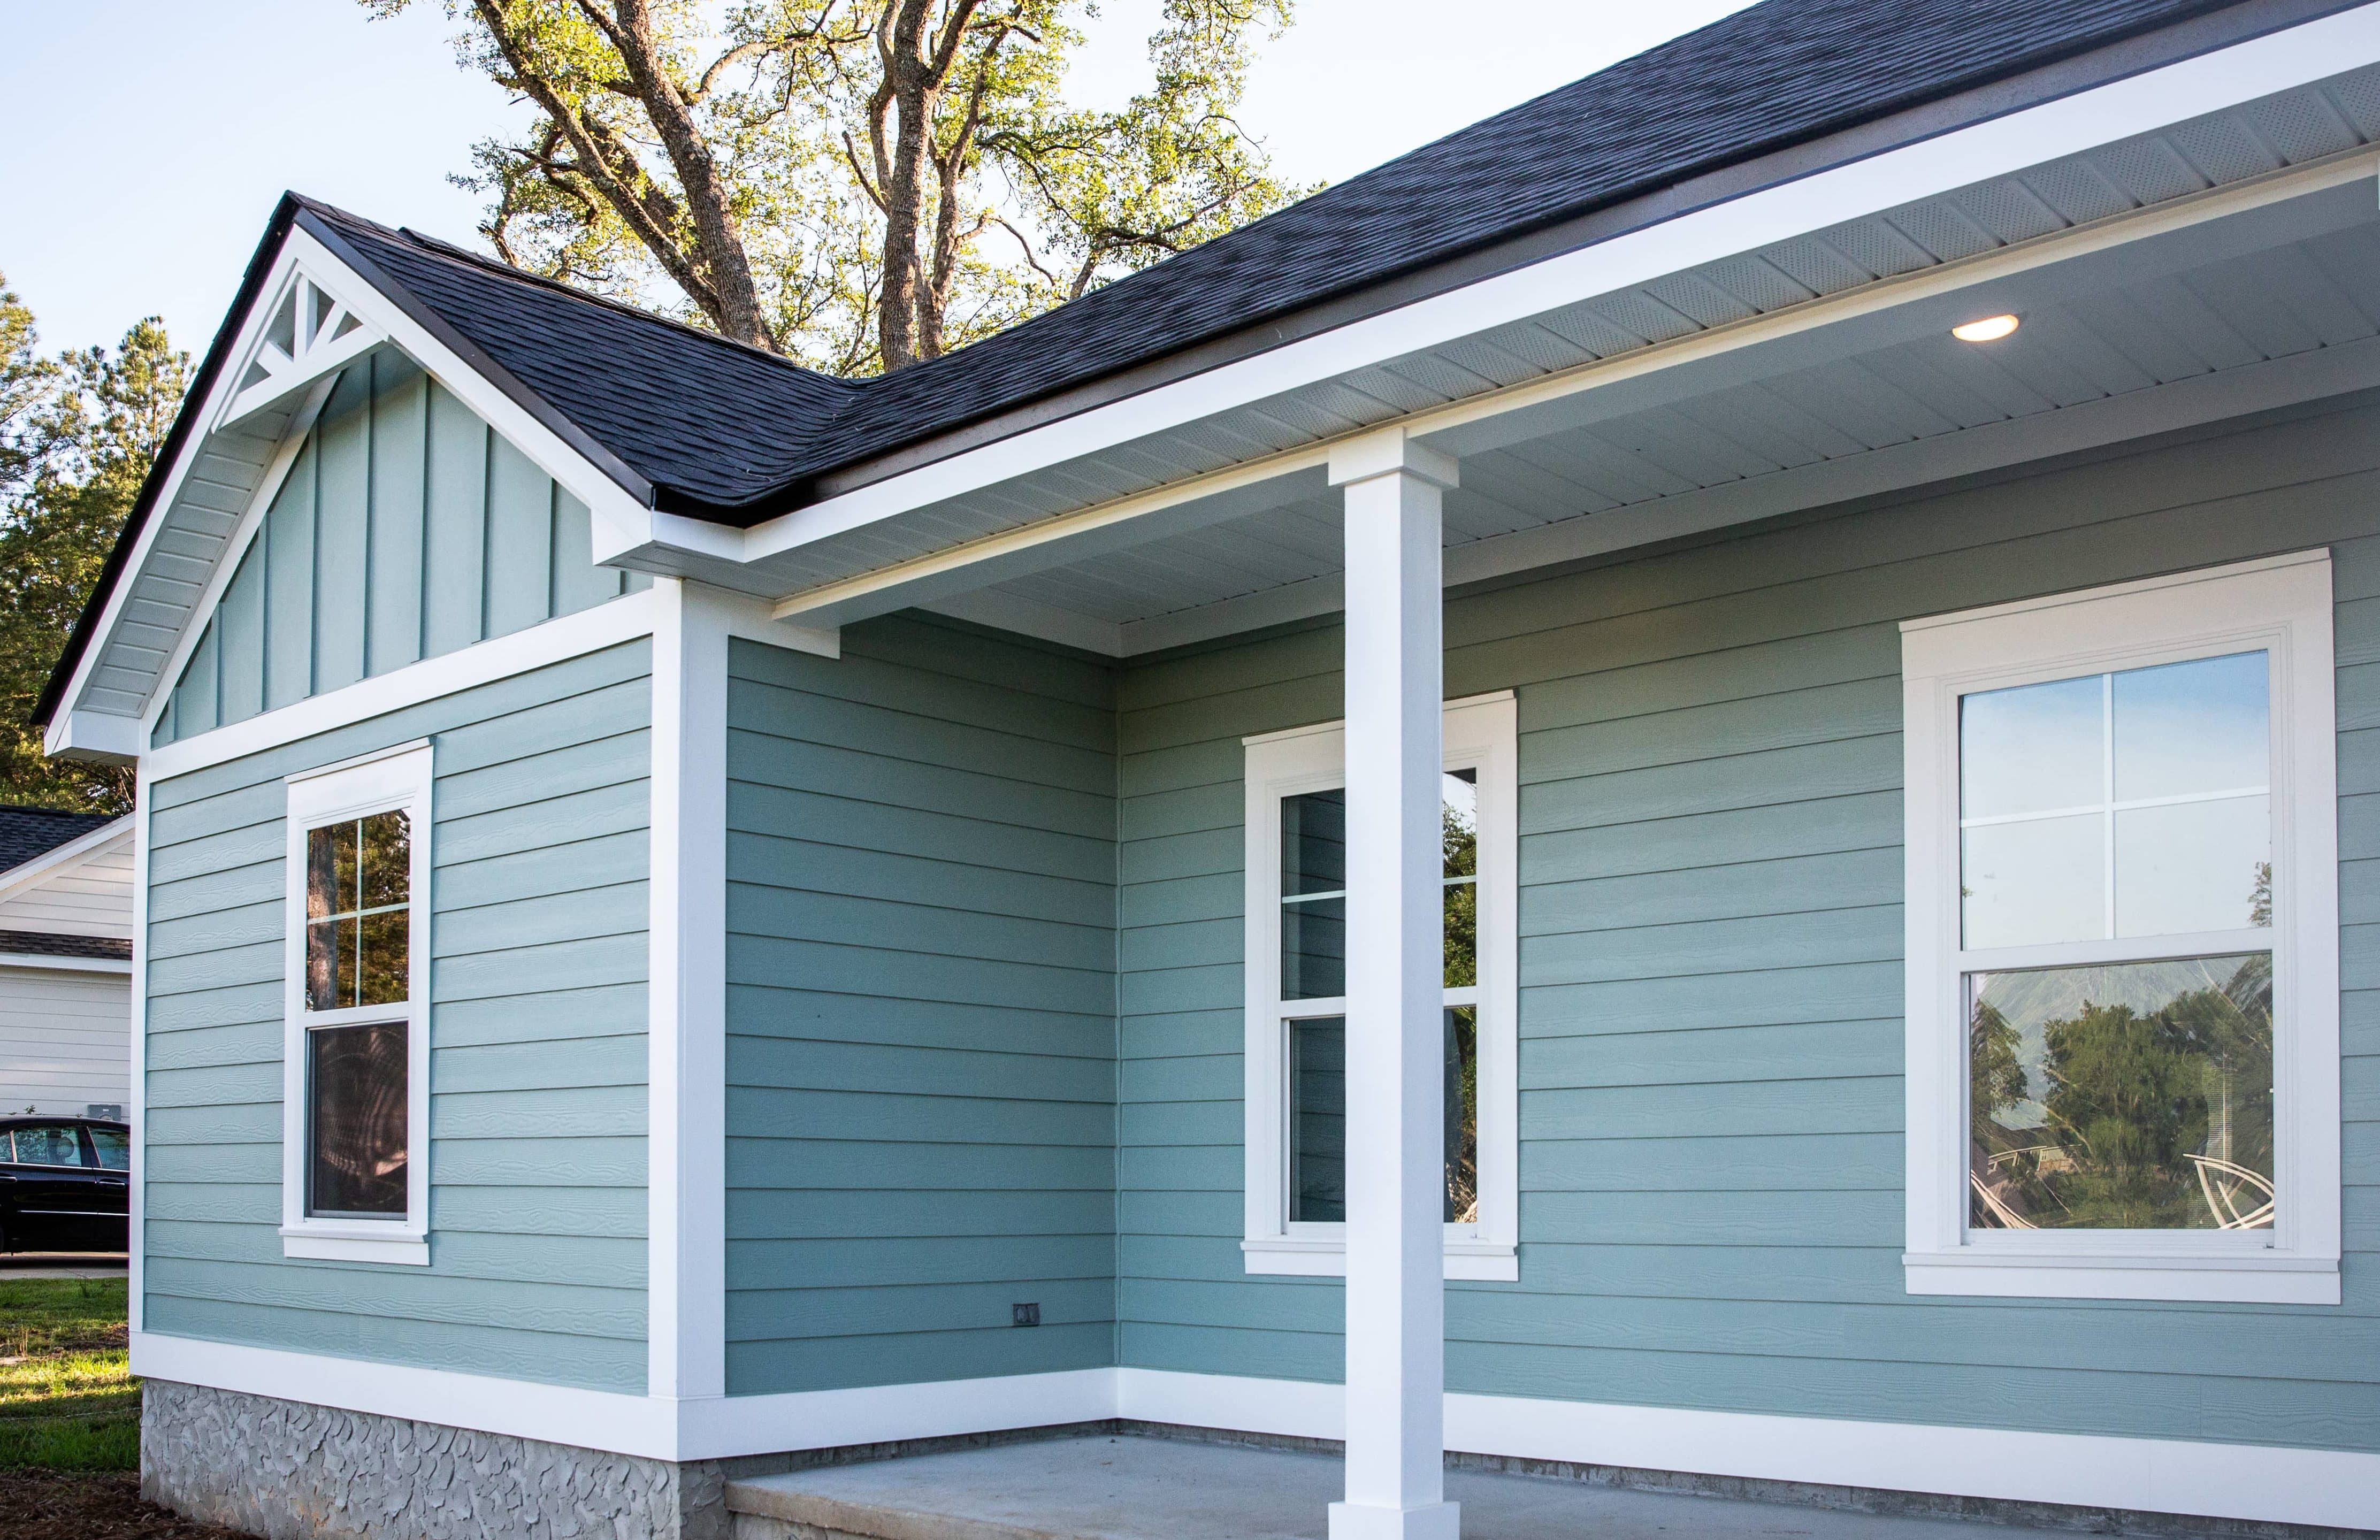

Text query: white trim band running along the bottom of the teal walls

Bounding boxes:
[116,1328,2380,1528]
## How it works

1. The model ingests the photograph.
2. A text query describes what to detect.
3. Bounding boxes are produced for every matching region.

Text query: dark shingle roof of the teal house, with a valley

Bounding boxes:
[304,0,2225,524]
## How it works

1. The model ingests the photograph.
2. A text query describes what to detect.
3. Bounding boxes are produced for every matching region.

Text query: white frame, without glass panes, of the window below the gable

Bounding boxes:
[281,740,433,1266]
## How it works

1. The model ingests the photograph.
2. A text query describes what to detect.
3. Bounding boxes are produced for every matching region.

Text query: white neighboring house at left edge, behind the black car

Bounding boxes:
[0,807,133,1118]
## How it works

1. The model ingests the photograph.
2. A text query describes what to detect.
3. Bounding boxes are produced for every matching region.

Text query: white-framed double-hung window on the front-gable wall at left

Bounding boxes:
[281,742,431,1264]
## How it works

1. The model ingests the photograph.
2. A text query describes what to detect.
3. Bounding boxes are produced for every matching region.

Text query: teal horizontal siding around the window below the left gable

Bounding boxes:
[143,640,652,1392]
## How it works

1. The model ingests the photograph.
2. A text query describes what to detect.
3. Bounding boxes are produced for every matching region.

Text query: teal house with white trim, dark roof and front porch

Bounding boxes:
[28,0,2380,1538]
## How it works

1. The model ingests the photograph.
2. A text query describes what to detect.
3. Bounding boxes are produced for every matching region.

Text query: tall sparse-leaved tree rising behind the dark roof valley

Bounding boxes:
[359,0,1302,376]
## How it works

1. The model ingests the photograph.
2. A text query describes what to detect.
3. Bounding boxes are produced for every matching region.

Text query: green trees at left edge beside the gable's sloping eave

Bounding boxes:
[0,279,190,811]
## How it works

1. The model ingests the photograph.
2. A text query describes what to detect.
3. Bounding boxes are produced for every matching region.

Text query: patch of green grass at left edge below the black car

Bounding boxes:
[0,1278,140,1471]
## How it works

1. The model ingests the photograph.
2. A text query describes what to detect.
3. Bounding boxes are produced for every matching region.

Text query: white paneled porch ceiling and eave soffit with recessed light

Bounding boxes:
[740,67,2380,655]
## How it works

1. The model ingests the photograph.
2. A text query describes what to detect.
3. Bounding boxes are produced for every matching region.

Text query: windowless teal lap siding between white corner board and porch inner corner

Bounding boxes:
[726,616,1116,1395]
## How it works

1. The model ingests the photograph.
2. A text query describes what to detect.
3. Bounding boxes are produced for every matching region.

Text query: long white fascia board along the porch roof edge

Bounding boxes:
[743,5,2380,562]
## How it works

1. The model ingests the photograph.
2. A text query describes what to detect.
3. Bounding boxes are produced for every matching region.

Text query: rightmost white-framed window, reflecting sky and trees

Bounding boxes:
[1902,552,2339,1304]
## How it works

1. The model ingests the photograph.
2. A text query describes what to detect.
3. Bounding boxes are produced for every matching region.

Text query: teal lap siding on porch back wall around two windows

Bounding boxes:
[1116,400,2380,1450]
